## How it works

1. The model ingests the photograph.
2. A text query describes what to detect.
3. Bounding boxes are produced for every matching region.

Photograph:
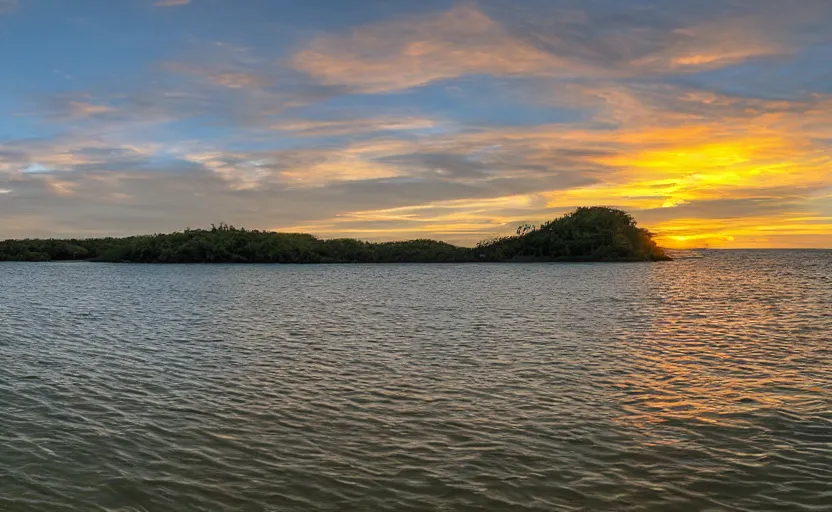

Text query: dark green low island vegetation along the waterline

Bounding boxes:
[0,207,669,263]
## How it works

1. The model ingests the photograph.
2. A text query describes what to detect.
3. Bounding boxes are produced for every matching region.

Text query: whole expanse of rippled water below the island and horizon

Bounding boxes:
[0,251,832,512]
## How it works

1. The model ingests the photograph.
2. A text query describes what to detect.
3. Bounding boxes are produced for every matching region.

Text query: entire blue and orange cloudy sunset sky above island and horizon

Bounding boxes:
[0,0,832,248]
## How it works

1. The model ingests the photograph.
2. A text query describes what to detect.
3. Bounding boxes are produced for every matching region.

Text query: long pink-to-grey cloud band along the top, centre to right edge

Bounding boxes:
[291,3,811,93]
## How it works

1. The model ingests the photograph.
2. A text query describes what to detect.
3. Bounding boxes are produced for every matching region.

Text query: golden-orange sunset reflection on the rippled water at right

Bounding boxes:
[614,253,830,433]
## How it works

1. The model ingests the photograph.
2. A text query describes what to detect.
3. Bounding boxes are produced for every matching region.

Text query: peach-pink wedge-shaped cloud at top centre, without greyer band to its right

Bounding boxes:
[292,5,567,92]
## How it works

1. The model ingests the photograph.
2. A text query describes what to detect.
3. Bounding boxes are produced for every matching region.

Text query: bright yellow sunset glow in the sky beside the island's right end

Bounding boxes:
[548,127,832,249]
